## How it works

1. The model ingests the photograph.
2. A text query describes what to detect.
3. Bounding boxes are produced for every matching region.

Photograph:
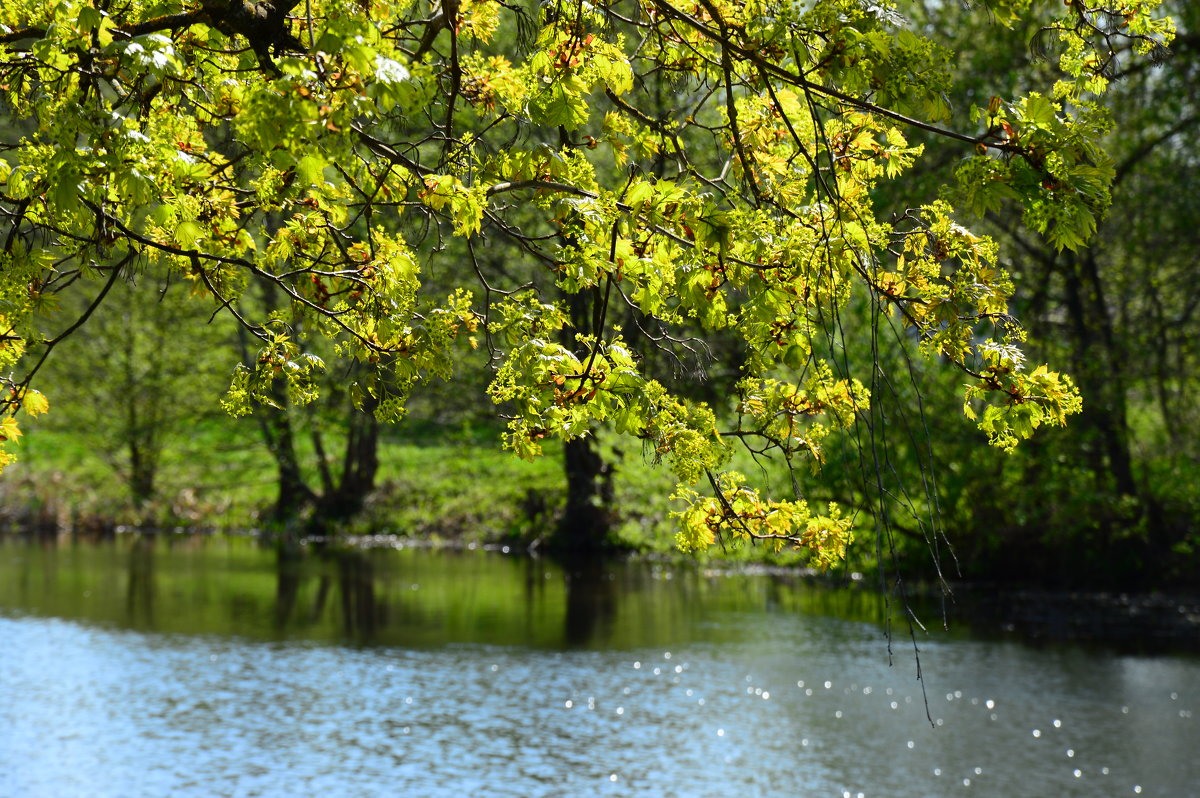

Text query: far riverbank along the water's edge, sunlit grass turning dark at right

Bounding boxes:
[0,418,1200,590]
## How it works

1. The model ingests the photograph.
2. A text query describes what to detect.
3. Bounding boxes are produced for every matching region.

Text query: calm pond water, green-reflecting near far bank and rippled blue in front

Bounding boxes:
[0,538,1200,798]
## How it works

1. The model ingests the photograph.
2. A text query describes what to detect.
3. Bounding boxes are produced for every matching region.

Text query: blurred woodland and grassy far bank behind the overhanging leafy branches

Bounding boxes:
[0,2,1200,588]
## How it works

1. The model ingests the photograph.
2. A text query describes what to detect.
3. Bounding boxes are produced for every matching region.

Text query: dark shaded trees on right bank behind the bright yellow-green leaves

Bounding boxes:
[787,4,1200,588]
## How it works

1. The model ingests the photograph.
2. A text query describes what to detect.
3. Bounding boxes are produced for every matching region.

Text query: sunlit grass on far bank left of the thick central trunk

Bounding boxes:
[0,418,563,540]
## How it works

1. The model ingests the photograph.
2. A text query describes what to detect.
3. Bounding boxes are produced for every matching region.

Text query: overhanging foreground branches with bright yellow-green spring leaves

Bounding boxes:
[0,0,1171,565]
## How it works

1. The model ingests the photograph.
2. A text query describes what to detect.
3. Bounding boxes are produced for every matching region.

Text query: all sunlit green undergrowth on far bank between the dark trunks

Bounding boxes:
[0,416,825,565]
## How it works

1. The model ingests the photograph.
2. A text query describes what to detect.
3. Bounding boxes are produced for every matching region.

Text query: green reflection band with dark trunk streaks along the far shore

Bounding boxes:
[0,536,902,648]
